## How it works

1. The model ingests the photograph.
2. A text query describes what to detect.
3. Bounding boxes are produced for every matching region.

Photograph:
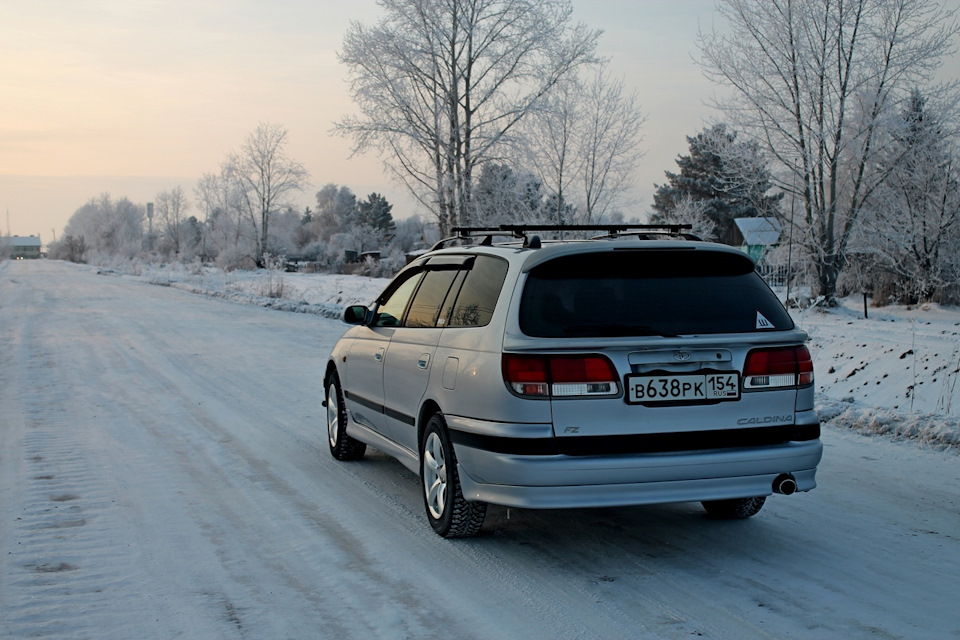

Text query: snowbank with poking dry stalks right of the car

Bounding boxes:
[794,299,960,449]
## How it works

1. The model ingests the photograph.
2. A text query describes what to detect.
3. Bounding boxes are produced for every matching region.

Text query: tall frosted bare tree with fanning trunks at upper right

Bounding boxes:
[700,0,958,304]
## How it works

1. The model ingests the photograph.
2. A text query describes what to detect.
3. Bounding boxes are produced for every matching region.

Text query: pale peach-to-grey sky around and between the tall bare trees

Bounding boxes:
[0,0,788,243]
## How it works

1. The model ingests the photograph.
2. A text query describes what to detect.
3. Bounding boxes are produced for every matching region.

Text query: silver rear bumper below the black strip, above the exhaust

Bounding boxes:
[456,439,823,509]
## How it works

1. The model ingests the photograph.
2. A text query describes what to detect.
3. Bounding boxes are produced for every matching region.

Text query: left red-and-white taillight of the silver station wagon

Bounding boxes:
[503,354,620,398]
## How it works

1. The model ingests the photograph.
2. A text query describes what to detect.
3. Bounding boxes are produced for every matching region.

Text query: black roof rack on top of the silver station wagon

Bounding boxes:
[430,224,701,251]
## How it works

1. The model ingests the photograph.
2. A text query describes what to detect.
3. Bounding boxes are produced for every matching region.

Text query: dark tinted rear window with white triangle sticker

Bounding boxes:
[520,249,794,338]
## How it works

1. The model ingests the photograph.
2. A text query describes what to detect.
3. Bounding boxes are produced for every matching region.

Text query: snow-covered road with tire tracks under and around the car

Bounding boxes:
[0,261,960,640]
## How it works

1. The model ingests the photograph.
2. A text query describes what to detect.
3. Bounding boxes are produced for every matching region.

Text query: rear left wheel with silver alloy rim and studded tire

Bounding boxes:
[420,414,487,538]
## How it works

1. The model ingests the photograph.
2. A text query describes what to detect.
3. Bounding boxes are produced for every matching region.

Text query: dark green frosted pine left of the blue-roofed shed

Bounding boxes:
[651,124,783,244]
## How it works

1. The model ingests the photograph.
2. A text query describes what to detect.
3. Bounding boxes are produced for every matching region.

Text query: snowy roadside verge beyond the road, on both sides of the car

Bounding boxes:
[118,265,960,449]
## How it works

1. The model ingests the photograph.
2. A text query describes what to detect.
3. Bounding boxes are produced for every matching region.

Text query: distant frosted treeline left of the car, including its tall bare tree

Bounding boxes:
[49,124,418,270]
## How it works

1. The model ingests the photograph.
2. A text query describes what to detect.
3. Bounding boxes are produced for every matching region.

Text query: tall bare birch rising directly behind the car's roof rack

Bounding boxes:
[335,0,599,233]
